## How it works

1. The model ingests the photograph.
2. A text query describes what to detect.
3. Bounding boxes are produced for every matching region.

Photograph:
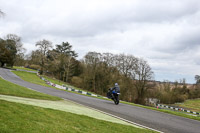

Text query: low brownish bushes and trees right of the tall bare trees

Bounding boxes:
[154,79,200,104]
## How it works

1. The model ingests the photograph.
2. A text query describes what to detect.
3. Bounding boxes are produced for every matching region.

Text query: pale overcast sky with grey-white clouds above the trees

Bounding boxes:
[0,0,200,83]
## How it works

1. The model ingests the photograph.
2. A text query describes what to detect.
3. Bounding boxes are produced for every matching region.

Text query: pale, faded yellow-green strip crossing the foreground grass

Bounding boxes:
[0,95,137,127]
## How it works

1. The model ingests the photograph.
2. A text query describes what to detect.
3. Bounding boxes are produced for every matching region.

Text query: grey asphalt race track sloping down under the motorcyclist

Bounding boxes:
[0,68,200,133]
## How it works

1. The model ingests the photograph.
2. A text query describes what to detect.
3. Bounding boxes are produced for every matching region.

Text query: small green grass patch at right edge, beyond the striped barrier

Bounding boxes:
[175,99,200,112]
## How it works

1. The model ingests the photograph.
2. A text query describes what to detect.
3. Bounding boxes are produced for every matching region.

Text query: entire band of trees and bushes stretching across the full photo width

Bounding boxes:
[0,34,200,104]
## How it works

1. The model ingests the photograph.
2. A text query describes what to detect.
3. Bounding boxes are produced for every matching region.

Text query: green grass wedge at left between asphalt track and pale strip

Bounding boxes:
[0,78,61,100]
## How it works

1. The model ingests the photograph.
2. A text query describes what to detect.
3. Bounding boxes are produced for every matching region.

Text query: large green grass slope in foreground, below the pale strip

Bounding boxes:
[0,100,153,133]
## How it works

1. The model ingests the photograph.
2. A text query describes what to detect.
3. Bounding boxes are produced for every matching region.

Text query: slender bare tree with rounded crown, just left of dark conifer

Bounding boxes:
[35,39,53,74]
